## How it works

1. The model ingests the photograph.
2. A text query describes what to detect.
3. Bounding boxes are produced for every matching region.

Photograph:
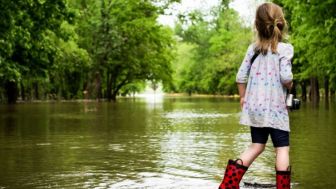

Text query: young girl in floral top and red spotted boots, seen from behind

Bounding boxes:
[219,3,294,189]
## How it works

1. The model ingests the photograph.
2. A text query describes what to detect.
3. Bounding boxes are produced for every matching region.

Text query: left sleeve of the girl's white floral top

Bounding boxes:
[236,44,254,83]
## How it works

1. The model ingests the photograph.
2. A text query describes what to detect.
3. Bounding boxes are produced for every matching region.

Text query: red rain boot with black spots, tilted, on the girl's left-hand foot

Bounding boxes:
[218,159,248,189]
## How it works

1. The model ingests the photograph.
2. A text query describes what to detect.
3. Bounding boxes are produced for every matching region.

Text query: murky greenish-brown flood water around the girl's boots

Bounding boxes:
[0,97,336,189]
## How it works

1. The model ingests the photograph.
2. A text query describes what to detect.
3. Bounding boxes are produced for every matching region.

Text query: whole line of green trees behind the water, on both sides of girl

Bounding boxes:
[0,0,336,103]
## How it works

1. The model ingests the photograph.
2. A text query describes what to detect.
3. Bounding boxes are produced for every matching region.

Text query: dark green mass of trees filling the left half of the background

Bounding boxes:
[0,0,178,102]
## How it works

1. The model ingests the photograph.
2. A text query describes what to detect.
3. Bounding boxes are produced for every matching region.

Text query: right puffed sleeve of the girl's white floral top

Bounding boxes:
[279,44,294,84]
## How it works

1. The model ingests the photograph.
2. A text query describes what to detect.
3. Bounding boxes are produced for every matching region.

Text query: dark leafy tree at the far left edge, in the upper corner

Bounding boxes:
[0,0,72,103]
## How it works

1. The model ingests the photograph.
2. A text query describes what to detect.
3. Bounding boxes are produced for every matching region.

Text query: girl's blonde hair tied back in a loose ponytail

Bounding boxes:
[254,3,287,54]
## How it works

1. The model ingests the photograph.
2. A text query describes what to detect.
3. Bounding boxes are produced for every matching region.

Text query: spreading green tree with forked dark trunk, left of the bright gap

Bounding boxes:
[74,0,174,101]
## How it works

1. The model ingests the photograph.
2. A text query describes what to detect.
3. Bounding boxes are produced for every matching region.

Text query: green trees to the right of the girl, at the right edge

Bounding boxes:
[276,0,336,97]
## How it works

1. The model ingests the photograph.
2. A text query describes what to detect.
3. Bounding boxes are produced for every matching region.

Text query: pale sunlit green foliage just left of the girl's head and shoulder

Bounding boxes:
[174,5,252,94]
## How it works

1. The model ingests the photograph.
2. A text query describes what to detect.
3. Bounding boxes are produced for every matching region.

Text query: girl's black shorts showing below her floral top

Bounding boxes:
[251,127,289,148]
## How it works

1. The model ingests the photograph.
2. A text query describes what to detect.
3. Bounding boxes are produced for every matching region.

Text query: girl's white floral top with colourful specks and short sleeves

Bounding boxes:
[236,43,294,131]
